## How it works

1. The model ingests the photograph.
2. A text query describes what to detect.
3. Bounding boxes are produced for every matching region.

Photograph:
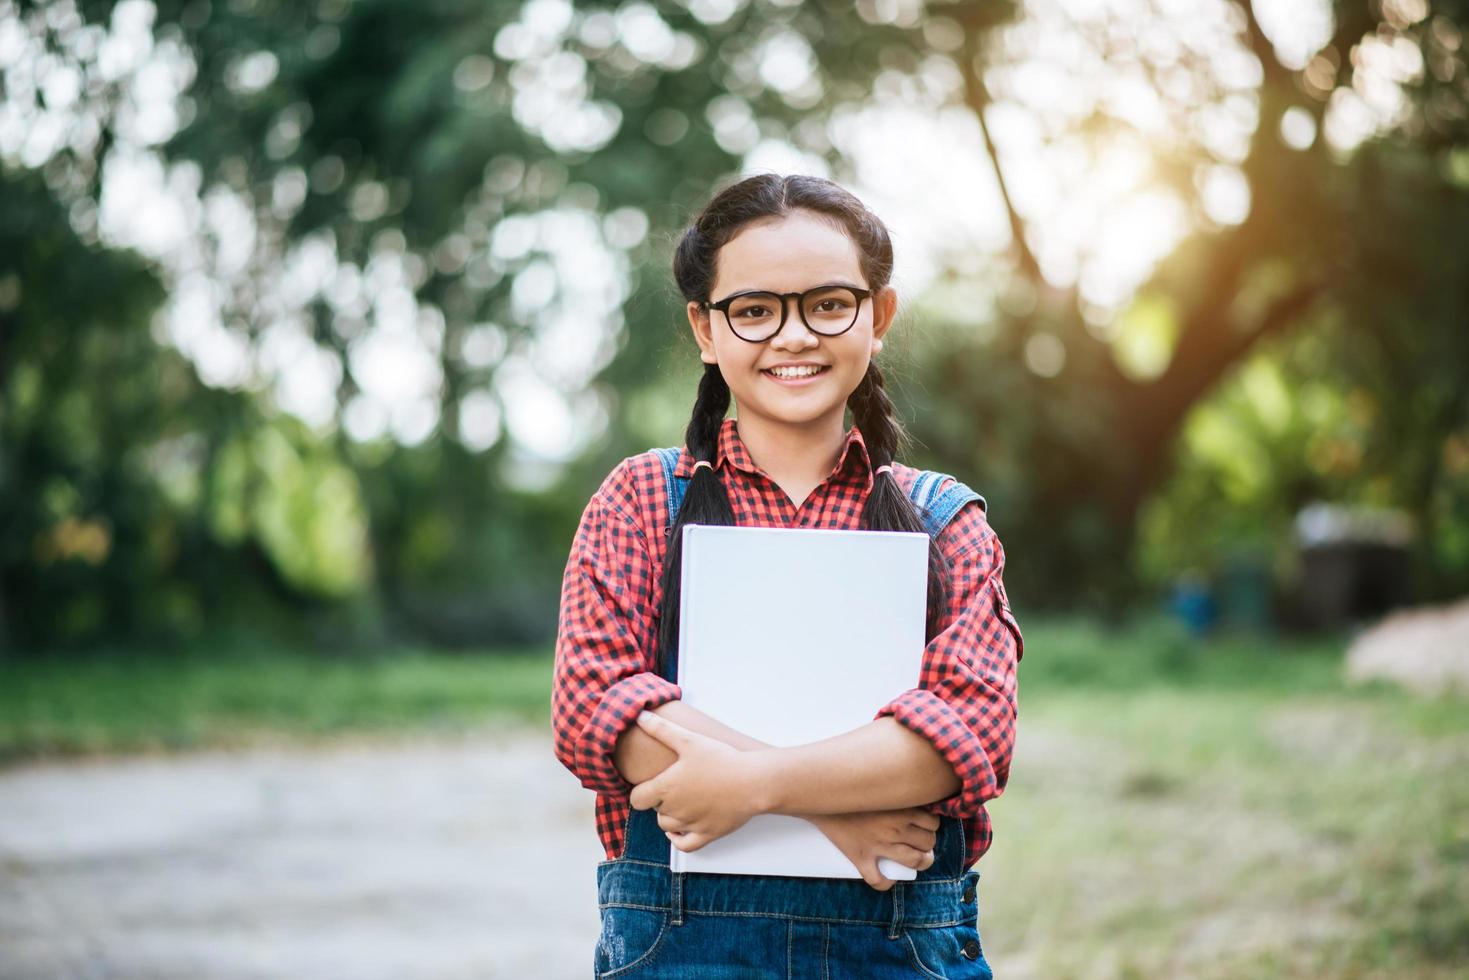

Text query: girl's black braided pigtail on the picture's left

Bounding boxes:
[657,364,735,676]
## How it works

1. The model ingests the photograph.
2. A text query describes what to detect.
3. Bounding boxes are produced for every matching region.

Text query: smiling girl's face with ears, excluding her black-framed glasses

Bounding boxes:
[689,210,898,430]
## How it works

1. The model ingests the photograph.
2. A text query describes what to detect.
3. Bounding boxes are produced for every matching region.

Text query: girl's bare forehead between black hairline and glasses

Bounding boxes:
[712,212,864,297]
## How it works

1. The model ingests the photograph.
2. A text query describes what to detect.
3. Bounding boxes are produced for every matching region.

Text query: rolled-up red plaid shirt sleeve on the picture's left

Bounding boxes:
[551,466,682,796]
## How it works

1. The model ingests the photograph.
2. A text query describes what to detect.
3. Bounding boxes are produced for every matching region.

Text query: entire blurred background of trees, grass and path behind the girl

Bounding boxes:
[0,0,1469,977]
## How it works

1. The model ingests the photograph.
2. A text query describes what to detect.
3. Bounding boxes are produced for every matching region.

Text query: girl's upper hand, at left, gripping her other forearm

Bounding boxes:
[630,711,761,851]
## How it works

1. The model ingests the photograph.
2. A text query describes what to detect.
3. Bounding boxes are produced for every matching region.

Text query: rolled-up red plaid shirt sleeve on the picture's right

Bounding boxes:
[876,501,1024,818]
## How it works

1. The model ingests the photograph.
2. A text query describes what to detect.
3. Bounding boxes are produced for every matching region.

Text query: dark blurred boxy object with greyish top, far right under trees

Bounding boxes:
[1293,504,1413,629]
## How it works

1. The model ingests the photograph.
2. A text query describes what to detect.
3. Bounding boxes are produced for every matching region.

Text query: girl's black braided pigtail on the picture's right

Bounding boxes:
[846,360,949,639]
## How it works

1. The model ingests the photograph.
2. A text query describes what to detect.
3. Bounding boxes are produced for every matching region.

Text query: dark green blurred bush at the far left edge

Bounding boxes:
[0,173,373,648]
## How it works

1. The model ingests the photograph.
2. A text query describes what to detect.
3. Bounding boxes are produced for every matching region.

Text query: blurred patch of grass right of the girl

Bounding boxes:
[980,623,1469,977]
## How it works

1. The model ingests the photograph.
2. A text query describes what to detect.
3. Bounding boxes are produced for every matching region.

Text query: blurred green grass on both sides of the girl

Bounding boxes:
[0,620,1469,980]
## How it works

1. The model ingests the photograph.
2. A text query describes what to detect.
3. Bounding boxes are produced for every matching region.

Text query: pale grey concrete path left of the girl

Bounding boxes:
[0,732,602,980]
